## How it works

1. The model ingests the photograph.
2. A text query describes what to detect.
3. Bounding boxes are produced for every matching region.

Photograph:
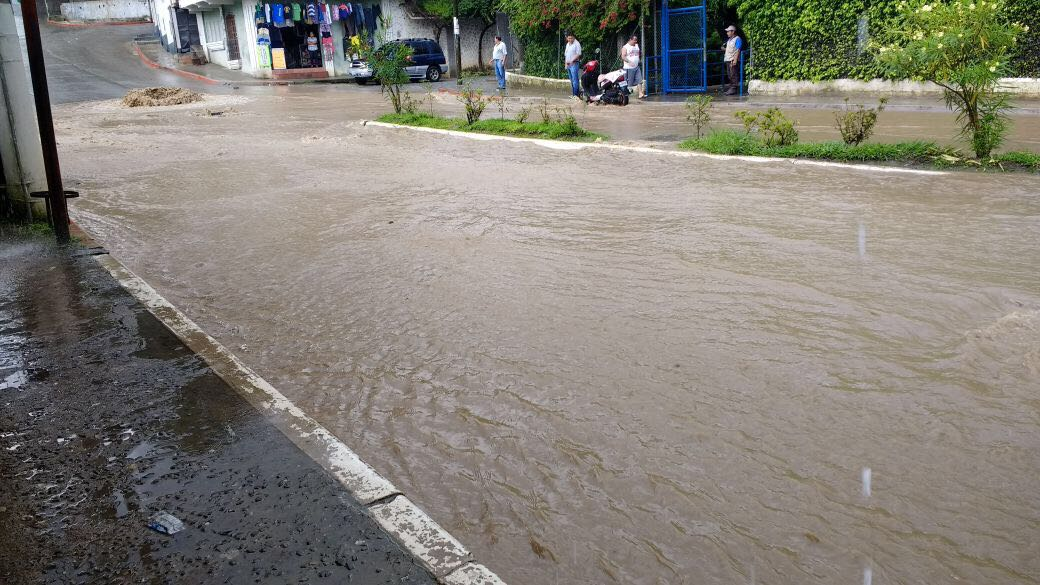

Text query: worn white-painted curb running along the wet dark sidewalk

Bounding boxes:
[95,254,504,585]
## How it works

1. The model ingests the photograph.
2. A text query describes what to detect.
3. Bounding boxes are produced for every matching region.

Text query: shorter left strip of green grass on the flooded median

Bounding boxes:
[379,113,606,143]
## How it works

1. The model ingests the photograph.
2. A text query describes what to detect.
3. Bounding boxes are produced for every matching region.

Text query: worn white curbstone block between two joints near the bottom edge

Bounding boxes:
[369,495,473,580]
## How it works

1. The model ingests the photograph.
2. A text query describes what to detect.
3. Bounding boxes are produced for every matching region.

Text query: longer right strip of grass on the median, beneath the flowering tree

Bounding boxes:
[679,130,1040,172]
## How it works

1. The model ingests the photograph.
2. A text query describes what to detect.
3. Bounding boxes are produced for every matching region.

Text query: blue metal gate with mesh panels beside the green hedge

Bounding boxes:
[660,0,708,94]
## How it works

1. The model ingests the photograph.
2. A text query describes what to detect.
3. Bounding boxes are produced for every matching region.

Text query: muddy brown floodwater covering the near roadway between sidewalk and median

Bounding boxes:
[59,95,1040,585]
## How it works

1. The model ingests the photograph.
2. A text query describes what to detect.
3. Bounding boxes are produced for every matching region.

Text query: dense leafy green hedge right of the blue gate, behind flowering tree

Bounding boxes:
[730,0,1040,81]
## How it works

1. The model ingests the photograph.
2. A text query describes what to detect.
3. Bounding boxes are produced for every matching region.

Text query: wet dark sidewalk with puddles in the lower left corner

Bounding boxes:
[0,230,436,585]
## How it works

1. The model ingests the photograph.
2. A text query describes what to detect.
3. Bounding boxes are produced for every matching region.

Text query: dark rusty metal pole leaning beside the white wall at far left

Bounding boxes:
[22,0,70,244]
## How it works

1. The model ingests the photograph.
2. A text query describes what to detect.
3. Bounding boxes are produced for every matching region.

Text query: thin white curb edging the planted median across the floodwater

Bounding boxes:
[362,121,948,176]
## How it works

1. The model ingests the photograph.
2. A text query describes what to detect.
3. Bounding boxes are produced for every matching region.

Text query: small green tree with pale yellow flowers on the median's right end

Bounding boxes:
[876,0,1029,158]
